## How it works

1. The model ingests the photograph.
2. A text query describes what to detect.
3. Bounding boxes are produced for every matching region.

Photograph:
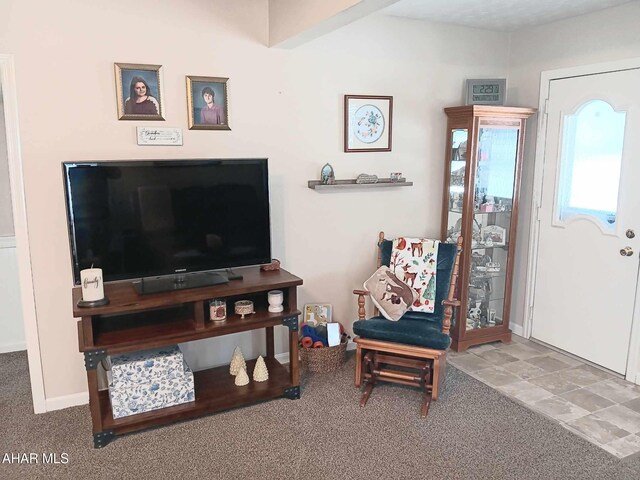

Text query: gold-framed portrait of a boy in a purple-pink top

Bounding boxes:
[187,76,231,130]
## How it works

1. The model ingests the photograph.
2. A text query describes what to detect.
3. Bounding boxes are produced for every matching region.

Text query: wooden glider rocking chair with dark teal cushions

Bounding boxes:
[353,232,462,417]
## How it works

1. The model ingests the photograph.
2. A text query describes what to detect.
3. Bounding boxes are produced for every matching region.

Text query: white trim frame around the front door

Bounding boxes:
[523,57,640,384]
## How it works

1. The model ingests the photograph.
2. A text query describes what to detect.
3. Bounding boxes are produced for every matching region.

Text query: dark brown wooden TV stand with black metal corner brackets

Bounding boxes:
[73,267,302,448]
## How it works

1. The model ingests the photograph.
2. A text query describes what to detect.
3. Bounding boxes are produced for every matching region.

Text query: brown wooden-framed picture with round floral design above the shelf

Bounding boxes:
[344,95,393,153]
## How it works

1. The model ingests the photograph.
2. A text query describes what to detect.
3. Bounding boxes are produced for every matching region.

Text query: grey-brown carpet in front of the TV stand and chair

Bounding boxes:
[0,352,640,480]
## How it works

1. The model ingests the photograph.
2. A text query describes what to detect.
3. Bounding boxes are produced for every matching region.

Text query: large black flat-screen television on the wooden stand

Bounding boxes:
[63,158,271,294]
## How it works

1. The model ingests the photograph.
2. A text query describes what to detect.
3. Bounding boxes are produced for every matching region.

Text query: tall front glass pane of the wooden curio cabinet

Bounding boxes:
[465,124,519,331]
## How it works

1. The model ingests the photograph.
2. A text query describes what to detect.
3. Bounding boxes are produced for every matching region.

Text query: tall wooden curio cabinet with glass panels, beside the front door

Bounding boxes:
[441,105,536,351]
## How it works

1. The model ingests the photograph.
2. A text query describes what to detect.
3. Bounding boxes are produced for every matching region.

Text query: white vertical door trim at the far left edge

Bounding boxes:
[0,54,47,413]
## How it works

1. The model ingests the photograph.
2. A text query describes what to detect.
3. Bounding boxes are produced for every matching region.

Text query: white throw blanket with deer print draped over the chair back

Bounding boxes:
[390,237,440,313]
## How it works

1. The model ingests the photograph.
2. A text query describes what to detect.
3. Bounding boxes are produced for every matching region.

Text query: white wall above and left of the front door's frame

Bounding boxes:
[508,2,640,338]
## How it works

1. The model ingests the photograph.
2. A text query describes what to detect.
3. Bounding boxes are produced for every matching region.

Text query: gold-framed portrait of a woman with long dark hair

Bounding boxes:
[115,63,164,120]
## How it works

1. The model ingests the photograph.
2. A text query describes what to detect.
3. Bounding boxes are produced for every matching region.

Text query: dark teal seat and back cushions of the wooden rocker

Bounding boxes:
[353,240,458,350]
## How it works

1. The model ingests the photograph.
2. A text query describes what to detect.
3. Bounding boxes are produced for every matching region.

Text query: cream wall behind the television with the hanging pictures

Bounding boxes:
[0,0,508,405]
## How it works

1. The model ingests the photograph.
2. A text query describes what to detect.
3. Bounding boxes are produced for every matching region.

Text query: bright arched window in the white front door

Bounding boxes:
[554,100,627,233]
